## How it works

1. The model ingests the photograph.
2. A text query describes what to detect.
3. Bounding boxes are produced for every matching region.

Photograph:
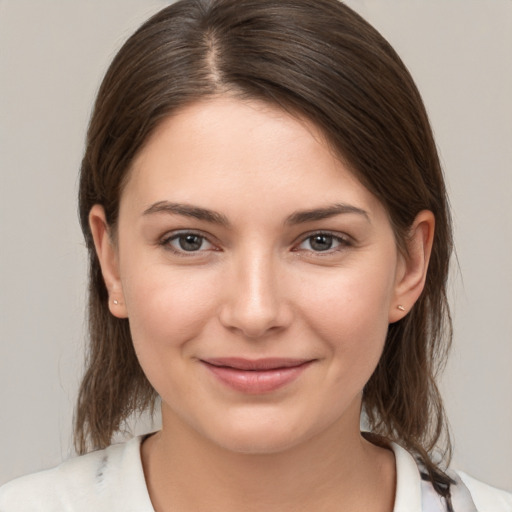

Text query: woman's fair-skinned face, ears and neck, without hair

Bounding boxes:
[90,97,434,512]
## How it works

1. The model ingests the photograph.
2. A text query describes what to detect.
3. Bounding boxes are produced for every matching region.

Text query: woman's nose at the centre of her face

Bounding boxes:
[219,249,293,339]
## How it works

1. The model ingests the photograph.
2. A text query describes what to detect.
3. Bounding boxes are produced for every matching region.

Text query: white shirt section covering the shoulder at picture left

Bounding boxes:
[0,437,152,512]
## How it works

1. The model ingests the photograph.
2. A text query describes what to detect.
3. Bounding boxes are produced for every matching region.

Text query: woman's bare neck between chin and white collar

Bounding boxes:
[142,406,395,512]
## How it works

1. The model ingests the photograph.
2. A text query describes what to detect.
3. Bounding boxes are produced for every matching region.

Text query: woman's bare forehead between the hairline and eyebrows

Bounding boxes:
[121,97,384,221]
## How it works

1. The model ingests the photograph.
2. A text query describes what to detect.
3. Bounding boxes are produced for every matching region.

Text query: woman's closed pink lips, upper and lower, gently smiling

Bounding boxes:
[201,357,314,394]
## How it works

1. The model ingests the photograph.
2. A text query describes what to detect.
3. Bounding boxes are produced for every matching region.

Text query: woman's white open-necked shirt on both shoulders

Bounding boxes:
[0,436,512,512]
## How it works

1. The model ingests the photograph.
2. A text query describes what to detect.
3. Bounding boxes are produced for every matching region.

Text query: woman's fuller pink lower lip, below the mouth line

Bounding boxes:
[204,361,312,395]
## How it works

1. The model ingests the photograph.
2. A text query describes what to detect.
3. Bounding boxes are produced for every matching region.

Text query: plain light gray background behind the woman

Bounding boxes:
[0,0,512,490]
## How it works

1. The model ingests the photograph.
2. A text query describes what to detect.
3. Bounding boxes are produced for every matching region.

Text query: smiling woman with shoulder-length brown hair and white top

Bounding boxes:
[0,0,512,512]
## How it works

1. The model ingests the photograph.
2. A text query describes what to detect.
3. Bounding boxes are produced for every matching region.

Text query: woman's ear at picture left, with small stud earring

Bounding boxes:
[89,204,128,318]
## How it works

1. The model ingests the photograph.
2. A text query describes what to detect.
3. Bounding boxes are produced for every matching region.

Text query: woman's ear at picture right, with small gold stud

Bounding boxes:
[389,210,435,323]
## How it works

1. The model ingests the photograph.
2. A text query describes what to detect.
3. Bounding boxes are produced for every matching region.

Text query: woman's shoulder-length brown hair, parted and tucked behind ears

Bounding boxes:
[75,0,452,493]
